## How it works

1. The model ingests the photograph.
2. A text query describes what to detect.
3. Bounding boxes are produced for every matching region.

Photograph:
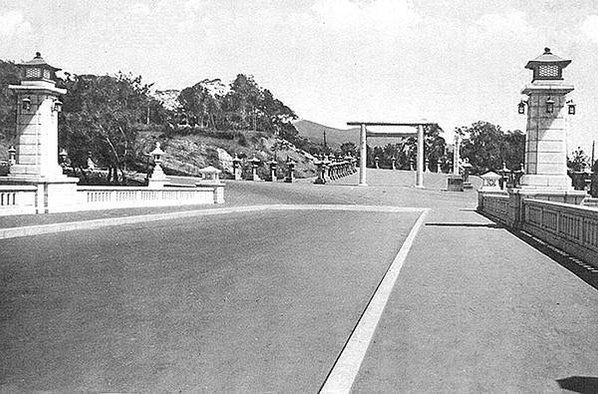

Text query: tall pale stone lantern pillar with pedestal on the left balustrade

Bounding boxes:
[0,52,79,213]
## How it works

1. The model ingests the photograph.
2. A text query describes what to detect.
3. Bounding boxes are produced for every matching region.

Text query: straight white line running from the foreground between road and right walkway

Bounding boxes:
[320,210,429,393]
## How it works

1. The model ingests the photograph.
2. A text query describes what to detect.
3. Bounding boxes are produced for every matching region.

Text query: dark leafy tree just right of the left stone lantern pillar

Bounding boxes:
[59,73,154,182]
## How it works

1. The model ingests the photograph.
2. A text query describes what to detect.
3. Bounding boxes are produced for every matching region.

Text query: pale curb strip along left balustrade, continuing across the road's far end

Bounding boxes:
[0,204,423,239]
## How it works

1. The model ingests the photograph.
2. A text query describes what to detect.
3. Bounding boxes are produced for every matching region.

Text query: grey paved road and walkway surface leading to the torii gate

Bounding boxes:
[0,170,598,393]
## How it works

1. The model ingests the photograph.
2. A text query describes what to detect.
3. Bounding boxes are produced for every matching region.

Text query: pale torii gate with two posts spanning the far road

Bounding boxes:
[347,122,438,188]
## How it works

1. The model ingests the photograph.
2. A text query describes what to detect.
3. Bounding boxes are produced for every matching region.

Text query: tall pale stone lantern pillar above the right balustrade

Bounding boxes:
[519,48,575,190]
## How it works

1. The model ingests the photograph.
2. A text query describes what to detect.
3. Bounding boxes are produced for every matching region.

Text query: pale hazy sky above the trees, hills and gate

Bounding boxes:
[0,0,598,153]
